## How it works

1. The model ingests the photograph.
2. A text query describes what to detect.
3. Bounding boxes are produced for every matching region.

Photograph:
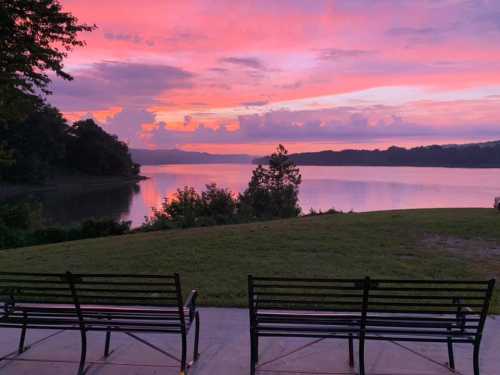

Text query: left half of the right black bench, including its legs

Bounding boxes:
[248,275,367,375]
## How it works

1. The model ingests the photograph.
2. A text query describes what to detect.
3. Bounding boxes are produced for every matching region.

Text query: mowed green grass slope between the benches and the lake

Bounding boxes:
[0,209,500,312]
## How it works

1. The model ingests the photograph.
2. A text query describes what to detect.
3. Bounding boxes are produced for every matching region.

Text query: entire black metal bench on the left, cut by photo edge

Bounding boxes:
[0,272,200,374]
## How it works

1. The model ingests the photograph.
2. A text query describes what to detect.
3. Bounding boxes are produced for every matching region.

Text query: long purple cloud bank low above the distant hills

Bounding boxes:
[119,106,500,148]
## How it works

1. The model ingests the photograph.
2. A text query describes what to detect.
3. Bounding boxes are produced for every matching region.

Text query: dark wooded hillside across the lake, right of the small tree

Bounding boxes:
[253,141,500,168]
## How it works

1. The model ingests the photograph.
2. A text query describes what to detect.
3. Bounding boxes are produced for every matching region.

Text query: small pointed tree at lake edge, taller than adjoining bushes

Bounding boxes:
[240,144,302,218]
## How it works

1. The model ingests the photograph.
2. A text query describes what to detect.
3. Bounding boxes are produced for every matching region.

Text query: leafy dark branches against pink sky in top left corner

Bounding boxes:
[0,0,95,116]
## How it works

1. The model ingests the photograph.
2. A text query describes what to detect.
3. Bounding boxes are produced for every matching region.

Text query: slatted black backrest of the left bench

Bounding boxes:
[0,272,184,320]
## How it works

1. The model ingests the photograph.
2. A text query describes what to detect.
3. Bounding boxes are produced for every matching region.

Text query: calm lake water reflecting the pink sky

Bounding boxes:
[11,164,500,226]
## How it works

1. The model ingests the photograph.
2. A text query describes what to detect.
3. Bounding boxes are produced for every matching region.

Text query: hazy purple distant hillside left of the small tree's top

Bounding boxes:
[130,149,254,165]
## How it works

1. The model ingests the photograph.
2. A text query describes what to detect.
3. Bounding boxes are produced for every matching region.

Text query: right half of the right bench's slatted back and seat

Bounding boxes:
[367,279,495,337]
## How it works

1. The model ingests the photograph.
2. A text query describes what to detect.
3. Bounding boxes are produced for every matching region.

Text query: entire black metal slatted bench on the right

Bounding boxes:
[248,275,495,375]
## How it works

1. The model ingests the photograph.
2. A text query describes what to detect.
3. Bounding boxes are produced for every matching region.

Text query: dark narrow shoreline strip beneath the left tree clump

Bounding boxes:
[0,176,149,201]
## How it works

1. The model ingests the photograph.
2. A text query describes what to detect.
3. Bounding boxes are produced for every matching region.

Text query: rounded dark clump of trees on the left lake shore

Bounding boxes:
[0,105,139,183]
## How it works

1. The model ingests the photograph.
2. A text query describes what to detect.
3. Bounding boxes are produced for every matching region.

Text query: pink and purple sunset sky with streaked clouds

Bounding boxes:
[50,0,500,155]
